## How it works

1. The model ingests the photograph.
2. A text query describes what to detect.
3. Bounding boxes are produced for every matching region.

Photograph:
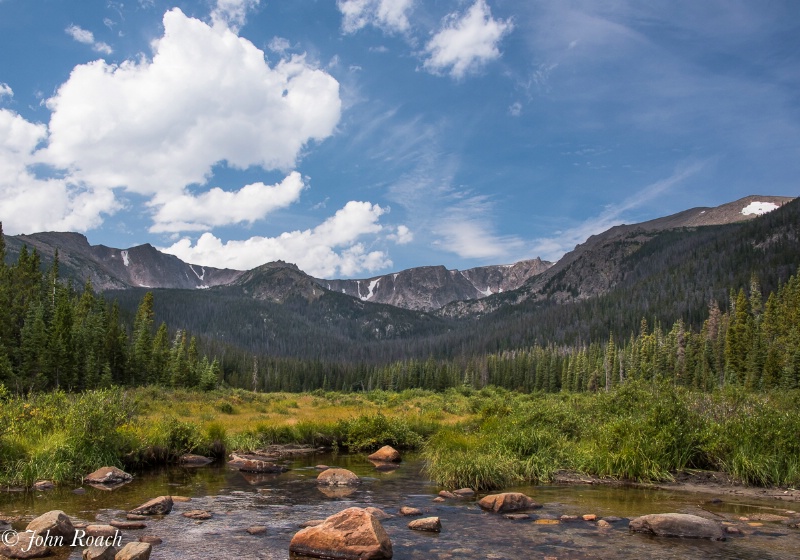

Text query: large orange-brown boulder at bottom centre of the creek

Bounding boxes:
[289,507,392,560]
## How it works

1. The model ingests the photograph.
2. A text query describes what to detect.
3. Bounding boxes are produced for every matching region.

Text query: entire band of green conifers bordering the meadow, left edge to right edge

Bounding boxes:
[0,217,800,393]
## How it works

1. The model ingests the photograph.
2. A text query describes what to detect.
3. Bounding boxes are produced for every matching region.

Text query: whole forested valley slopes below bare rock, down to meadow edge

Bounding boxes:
[0,197,800,392]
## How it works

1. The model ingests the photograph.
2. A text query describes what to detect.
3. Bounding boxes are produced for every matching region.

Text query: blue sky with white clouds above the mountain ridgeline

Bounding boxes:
[0,0,800,278]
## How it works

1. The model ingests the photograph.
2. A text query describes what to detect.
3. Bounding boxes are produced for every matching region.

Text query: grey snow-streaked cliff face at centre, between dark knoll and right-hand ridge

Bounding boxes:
[317,258,552,311]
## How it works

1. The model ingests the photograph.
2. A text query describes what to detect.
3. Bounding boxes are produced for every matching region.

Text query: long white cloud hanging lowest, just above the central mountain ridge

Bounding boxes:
[162,201,392,278]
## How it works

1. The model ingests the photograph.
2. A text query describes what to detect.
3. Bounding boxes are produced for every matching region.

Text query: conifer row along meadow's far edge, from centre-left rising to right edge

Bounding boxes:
[216,275,800,392]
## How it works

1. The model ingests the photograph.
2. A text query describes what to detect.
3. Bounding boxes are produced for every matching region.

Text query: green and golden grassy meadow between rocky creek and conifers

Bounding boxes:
[0,382,800,490]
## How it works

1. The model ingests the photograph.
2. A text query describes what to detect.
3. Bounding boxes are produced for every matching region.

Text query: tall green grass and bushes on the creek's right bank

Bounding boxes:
[424,382,800,490]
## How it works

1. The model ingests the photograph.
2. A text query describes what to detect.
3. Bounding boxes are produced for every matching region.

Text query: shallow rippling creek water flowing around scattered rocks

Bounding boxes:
[0,455,800,560]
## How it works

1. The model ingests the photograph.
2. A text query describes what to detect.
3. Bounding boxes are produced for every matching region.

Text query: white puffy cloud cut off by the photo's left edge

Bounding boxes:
[0,109,118,235]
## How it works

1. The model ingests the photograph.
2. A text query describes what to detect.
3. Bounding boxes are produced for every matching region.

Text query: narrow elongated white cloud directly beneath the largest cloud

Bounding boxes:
[150,171,305,233]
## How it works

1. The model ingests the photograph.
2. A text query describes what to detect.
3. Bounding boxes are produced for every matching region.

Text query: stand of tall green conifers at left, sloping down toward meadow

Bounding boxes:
[0,225,221,394]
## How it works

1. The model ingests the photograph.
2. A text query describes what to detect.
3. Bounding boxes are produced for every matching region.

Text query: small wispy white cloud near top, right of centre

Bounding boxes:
[423,0,514,79]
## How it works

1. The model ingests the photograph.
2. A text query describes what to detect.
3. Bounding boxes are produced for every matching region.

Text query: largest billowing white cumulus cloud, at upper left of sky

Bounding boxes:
[46,9,341,195]
